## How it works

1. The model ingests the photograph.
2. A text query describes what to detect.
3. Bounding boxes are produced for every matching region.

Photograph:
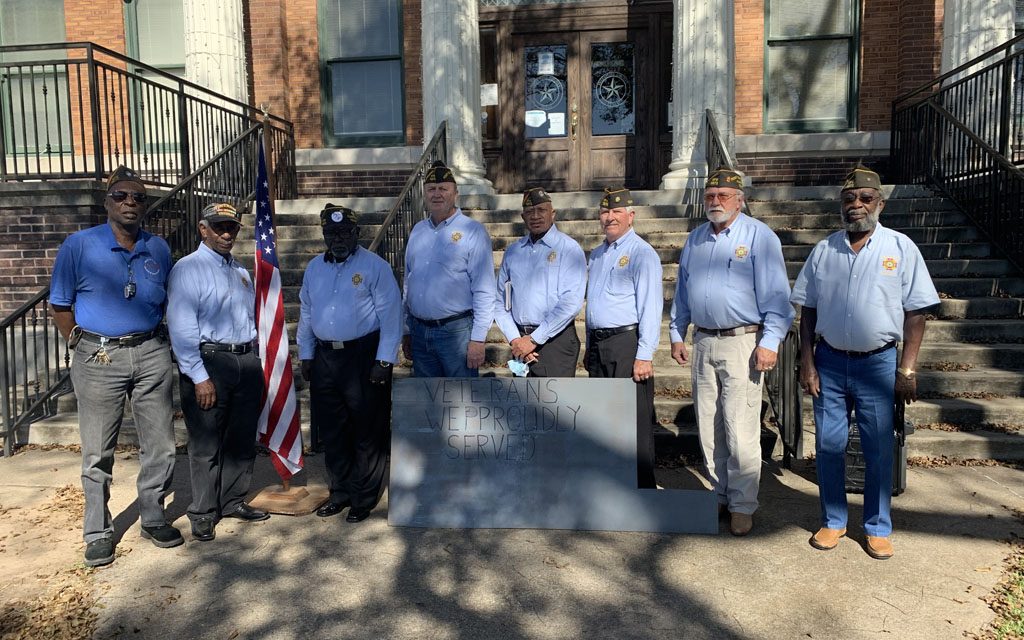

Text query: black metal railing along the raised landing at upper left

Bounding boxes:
[0,42,296,188]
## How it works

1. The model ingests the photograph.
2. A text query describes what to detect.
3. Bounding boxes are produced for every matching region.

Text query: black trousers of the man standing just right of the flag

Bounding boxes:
[309,332,391,509]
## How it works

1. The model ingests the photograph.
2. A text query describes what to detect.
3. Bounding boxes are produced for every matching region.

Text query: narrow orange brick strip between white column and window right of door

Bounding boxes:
[733,0,765,135]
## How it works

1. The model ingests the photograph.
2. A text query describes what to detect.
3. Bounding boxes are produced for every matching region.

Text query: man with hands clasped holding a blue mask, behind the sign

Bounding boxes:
[495,186,587,378]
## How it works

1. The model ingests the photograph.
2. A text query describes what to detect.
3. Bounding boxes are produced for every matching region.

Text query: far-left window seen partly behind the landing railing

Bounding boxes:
[0,0,72,153]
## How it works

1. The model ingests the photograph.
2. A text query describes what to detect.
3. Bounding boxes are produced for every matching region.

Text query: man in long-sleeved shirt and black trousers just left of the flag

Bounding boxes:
[167,203,270,542]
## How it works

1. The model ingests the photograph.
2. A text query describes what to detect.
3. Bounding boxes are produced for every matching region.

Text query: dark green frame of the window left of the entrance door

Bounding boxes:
[316,0,407,148]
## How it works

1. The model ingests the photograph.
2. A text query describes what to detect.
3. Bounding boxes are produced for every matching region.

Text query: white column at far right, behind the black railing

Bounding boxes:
[942,0,1016,73]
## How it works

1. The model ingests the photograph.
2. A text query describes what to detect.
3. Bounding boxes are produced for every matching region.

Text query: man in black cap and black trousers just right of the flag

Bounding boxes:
[298,204,401,522]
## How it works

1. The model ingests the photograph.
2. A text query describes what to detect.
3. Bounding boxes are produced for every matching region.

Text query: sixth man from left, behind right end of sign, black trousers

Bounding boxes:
[584,187,665,488]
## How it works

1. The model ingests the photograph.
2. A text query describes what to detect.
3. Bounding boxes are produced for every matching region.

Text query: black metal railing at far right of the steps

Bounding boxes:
[890,35,1024,268]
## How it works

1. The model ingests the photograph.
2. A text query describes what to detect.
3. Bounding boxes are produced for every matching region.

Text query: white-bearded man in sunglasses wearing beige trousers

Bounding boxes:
[669,169,795,536]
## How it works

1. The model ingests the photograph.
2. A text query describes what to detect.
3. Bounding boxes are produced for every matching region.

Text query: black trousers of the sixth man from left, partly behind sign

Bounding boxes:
[587,329,655,488]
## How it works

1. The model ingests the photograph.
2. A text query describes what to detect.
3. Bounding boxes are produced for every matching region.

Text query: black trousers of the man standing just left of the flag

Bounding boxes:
[178,351,263,519]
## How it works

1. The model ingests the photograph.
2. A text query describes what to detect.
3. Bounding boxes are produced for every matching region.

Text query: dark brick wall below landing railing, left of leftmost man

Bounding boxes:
[0,188,106,317]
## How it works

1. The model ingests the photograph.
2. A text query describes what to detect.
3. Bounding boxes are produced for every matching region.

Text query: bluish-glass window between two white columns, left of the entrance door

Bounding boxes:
[319,0,404,146]
